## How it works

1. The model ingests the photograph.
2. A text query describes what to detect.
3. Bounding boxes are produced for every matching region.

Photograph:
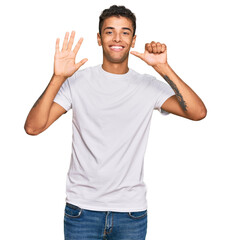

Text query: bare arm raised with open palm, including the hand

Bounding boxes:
[24,32,87,135]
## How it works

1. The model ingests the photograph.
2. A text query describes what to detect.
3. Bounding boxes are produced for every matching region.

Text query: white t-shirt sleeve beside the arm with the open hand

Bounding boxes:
[53,78,72,111]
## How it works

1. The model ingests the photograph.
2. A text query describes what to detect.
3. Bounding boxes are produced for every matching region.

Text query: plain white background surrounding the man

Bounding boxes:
[0,0,231,240]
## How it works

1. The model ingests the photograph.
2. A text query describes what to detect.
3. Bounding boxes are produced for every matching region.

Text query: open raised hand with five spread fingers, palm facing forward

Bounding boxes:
[54,31,88,78]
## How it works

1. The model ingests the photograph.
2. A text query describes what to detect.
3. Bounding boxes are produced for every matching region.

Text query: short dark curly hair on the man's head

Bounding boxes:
[99,5,136,36]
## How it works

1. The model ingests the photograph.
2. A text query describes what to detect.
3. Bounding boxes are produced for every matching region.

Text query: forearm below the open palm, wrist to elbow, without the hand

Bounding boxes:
[24,75,65,132]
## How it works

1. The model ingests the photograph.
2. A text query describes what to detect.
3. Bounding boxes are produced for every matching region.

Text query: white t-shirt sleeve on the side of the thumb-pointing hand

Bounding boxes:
[152,77,175,115]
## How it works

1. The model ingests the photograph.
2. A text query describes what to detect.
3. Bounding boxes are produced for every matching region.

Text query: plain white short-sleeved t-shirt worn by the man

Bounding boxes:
[54,65,175,212]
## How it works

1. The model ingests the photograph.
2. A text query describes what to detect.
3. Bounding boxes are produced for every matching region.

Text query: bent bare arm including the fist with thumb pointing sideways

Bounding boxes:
[131,42,207,120]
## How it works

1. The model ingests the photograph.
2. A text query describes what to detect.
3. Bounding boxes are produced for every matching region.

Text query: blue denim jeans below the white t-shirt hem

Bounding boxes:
[64,203,147,240]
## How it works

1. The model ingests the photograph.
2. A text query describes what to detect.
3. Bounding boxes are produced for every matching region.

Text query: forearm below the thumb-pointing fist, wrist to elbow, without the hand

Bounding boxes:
[153,63,206,117]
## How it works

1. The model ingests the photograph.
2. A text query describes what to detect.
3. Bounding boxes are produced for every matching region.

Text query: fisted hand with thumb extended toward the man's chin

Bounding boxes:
[130,42,167,67]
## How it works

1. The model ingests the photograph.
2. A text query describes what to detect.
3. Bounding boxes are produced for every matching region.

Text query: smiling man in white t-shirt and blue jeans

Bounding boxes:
[25,5,206,240]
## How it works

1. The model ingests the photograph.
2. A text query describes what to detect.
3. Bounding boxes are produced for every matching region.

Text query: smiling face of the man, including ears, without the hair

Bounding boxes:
[97,16,136,63]
